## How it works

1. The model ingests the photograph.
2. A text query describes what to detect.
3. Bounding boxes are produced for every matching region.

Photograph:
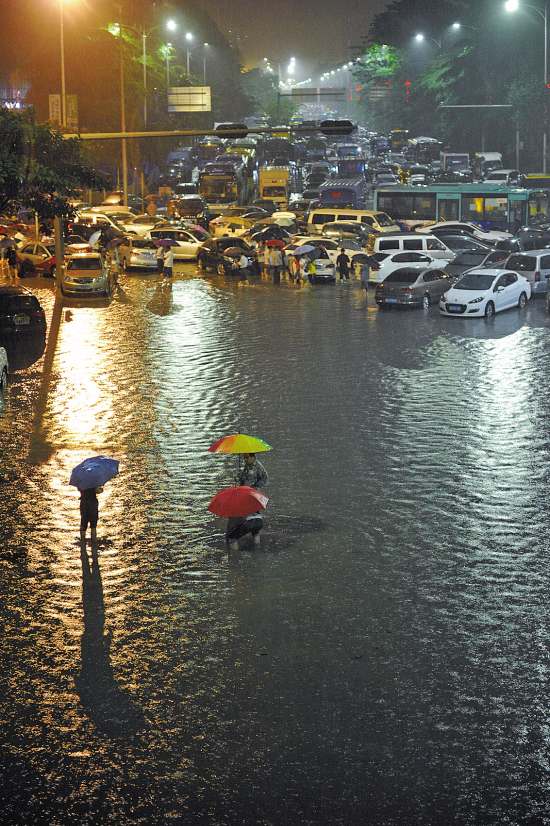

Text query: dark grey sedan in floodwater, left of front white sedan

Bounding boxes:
[374,264,452,310]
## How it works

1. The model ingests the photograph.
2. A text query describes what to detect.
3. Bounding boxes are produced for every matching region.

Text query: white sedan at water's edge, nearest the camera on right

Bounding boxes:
[439,269,531,317]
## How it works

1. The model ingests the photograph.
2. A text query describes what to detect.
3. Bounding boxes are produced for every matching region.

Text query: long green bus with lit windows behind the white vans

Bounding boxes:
[374,183,550,233]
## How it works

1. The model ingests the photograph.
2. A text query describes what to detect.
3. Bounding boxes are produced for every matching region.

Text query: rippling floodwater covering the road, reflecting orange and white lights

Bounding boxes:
[0,265,550,826]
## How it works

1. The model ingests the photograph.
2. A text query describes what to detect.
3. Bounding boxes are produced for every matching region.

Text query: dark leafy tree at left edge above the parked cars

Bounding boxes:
[0,109,105,222]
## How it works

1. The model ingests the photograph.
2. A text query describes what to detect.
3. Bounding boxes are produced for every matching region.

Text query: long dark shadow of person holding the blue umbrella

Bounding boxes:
[75,542,145,739]
